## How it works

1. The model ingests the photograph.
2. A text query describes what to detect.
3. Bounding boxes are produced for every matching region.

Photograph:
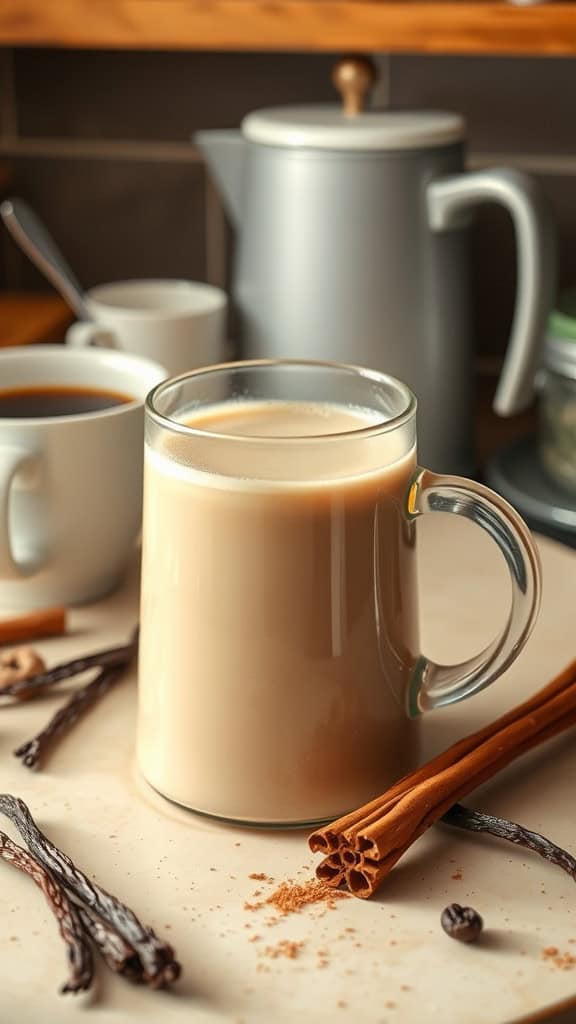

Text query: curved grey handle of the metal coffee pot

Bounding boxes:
[427,168,556,416]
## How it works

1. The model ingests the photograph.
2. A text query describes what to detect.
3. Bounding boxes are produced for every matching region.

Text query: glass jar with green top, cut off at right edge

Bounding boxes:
[539,329,576,494]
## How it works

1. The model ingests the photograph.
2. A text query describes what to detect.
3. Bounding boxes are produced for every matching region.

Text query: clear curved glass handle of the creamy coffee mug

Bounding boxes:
[407,469,540,717]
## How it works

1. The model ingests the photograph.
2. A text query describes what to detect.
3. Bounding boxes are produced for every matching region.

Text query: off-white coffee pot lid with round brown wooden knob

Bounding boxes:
[242,57,464,151]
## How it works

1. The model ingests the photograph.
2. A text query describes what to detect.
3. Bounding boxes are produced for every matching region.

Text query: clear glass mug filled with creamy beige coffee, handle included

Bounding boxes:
[137,361,540,824]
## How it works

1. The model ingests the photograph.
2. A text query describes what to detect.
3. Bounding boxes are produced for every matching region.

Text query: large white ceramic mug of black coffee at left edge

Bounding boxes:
[0,345,166,609]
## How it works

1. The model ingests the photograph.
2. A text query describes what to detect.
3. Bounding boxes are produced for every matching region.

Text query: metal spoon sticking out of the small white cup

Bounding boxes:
[0,199,92,321]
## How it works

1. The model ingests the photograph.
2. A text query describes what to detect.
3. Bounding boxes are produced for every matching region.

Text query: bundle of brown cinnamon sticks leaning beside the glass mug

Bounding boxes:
[308,659,576,899]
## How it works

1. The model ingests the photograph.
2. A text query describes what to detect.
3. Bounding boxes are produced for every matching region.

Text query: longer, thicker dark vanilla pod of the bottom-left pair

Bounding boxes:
[0,794,180,988]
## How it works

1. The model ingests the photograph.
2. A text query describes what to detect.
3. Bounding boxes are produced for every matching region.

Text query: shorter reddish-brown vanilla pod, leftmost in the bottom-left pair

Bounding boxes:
[0,831,94,993]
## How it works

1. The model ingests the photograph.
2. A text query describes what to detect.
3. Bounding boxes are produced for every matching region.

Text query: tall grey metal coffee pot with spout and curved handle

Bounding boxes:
[196,57,553,474]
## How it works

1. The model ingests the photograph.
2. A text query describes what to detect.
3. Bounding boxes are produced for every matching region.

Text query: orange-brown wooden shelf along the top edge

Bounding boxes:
[0,0,576,55]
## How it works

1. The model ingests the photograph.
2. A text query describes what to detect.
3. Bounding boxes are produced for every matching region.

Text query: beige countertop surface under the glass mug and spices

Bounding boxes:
[0,515,576,1024]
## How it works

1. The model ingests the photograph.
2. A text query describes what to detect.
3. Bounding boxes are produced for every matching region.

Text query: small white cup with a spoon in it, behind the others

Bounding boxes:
[66,281,228,377]
